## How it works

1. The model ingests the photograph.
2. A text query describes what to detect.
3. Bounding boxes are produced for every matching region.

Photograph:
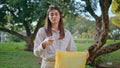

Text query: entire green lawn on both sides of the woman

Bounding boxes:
[0,39,120,68]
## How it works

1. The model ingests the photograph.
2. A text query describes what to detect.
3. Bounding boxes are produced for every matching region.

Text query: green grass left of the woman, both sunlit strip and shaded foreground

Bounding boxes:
[0,42,40,68]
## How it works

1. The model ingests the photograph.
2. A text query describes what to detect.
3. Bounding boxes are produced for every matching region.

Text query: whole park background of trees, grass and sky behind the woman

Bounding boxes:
[0,0,120,68]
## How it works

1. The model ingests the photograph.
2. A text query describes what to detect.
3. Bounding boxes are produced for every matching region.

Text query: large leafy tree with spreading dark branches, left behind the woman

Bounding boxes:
[0,0,74,51]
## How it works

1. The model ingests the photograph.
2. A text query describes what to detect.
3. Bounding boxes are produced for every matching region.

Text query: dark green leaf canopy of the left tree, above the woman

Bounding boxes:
[0,0,77,30]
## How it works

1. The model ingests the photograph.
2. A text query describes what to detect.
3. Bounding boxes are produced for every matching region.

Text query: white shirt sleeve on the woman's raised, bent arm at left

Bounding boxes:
[34,28,44,57]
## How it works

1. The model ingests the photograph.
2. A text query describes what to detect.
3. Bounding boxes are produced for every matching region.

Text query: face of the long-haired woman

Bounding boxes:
[49,9,60,24]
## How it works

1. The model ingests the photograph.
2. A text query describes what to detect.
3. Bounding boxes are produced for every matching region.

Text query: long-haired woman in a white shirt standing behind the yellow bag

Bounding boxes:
[34,5,77,68]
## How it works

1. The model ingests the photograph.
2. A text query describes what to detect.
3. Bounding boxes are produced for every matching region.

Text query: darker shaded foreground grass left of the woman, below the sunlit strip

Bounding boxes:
[0,51,40,68]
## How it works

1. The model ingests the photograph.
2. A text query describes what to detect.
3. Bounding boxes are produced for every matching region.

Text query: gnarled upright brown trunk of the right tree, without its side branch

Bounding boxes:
[88,0,112,65]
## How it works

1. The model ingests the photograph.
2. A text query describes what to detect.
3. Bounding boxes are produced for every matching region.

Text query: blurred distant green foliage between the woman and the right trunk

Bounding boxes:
[64,16,95,38]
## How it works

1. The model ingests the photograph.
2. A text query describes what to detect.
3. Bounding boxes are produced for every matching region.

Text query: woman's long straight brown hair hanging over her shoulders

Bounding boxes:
[45,5,65,39]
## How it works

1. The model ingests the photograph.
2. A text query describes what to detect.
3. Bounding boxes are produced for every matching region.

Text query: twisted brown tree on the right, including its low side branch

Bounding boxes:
[76,0,120,65]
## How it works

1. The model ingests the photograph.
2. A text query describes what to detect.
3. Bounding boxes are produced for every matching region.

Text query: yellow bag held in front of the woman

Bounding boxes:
[55,51,88,68]
